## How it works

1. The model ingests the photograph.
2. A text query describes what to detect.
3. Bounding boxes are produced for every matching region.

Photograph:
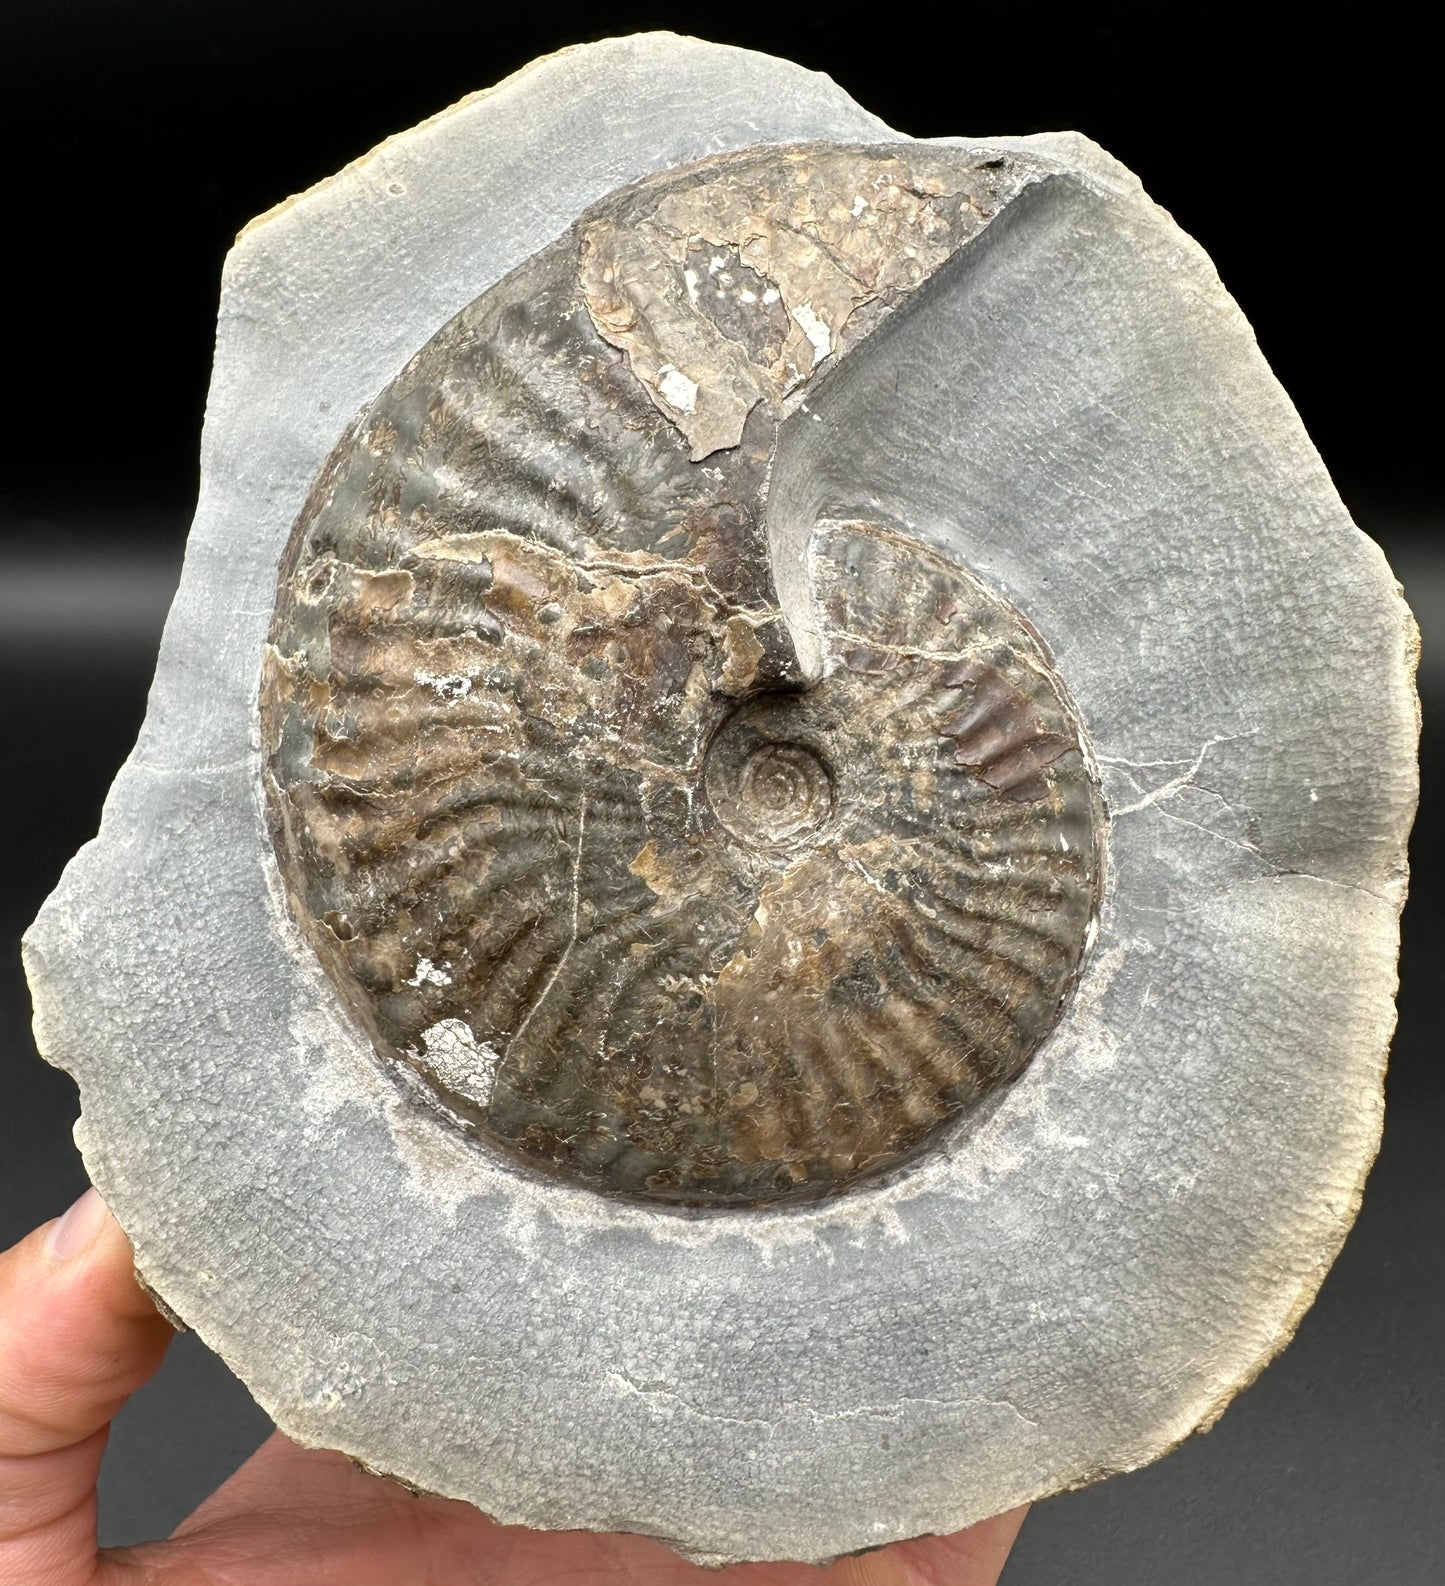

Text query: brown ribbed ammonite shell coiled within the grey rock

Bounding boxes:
[262,149,1099,1205]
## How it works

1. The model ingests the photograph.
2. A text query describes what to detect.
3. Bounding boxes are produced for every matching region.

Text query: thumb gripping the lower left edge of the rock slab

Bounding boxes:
[0,1190,171,1586]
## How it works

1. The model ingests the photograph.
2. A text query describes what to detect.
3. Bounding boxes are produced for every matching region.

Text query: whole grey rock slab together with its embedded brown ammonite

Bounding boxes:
[27,35,1416,1562]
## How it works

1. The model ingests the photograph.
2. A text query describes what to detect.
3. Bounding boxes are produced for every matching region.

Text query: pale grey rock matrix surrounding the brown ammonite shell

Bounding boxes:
[27,36,1416,1559]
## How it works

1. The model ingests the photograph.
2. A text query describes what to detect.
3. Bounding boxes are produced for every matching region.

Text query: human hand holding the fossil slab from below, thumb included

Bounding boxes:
[0,1190,1023,1586]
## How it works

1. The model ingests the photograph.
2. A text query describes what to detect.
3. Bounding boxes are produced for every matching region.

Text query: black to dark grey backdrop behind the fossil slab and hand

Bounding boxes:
[0,0,1445,1586]
